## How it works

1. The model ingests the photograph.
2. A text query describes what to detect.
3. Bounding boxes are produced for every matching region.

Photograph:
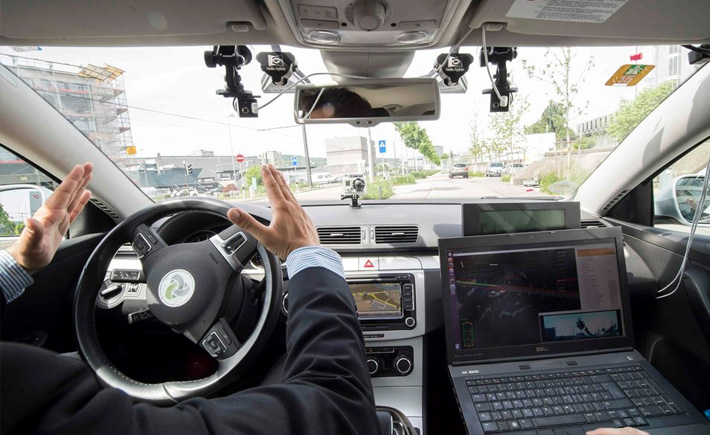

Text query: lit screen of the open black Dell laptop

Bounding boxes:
[447,243,622,350]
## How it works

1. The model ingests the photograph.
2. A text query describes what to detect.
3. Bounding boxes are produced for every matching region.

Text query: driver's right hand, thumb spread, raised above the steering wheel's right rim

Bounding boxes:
[227,165,320,259]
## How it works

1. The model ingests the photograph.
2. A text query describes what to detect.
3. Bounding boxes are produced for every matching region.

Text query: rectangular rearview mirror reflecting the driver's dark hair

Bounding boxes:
[294,79,440,127]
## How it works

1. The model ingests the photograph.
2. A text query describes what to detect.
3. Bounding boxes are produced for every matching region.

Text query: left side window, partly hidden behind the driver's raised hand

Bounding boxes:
[0,147,56,249]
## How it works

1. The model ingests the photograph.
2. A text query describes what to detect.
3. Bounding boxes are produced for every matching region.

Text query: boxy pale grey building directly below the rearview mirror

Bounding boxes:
[325,136,375,175]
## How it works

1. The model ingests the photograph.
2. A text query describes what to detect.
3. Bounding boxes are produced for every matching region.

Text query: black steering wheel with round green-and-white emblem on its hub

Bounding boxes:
[74,198,283,404]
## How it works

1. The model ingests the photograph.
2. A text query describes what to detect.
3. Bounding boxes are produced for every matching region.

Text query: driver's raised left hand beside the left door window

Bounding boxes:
[7,163,94,270]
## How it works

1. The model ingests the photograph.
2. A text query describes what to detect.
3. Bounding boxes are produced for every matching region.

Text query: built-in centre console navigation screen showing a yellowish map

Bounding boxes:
[350,282,402,320]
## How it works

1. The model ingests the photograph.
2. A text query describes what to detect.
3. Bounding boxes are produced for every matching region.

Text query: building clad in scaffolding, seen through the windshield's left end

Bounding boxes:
[3,56,137,175]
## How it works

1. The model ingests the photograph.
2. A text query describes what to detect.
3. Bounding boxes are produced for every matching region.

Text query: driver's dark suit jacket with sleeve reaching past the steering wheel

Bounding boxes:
[0,268,378,435]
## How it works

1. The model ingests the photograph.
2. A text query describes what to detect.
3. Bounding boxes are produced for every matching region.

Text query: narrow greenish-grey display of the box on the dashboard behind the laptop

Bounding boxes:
[479,210,565,235]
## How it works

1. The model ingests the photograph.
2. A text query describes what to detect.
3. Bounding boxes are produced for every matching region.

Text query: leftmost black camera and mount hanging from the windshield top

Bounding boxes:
[205,45,259,118]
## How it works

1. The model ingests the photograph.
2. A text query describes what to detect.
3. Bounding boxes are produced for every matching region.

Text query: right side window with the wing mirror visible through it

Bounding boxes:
[653,139,710,235]
